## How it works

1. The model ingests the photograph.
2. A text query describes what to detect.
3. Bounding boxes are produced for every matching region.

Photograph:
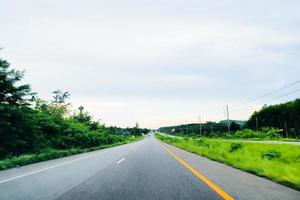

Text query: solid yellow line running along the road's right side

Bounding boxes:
[159,143,234,200]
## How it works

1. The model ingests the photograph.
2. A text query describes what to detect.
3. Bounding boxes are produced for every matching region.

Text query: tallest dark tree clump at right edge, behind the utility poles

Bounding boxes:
[246,99,300,137]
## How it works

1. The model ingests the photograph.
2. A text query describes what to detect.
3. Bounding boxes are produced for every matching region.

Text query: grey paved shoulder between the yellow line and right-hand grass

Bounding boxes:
[158,141,300,200]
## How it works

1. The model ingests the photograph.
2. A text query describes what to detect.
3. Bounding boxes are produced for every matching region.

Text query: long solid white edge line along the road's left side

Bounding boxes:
[0,150,112,184]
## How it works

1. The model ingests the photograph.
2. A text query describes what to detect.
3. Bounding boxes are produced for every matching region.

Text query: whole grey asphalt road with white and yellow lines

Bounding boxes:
[0,136,300,200]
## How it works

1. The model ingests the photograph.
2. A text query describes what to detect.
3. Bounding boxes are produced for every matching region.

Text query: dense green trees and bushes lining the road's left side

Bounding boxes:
[0,59,148,159]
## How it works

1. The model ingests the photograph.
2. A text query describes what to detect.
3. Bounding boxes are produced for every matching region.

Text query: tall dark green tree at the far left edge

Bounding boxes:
[0,59,36,157]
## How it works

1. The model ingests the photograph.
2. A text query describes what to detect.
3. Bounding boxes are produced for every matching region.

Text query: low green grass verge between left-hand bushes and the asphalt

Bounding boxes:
[0,136,143,170]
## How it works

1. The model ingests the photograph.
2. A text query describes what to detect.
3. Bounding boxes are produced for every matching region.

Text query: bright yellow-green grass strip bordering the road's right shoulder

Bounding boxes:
[155,134,300,190]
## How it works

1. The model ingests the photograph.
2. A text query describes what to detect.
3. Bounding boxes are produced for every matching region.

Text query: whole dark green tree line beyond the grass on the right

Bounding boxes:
[159,99,300,138]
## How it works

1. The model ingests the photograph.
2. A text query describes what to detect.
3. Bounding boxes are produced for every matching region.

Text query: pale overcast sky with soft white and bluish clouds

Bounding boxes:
[0,0,300,128]
